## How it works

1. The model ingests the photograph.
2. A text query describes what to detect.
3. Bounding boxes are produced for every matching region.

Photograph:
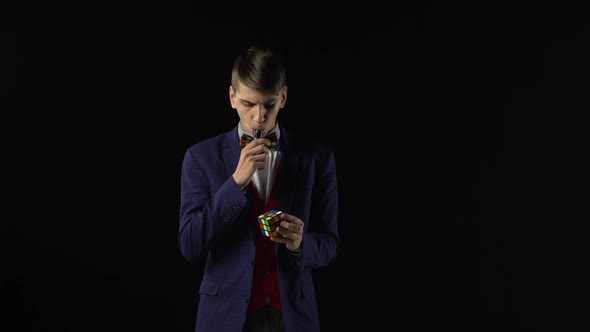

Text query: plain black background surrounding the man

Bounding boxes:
[5,1,590,332]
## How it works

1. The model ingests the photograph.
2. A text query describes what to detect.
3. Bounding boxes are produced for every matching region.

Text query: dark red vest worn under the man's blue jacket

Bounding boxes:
[247,182,281,315]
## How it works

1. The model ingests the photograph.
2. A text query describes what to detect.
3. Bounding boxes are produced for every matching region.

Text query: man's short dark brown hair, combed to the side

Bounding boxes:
[231,45,287,94]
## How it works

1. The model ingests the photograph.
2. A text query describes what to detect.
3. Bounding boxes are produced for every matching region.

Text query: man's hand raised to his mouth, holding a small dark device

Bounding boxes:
[232,138,270,189]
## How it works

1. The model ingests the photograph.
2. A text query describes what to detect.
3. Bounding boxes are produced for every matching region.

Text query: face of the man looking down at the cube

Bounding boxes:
[229,82,287,136]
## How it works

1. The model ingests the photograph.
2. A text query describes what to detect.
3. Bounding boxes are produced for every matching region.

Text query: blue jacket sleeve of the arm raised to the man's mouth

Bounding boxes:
[178,149,248,263]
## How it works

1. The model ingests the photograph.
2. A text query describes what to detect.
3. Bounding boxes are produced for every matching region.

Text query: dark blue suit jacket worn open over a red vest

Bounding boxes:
[179,126,339,332]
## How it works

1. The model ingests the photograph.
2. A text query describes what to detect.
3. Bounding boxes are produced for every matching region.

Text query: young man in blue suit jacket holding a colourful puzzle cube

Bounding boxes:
[179,46,339,332]
